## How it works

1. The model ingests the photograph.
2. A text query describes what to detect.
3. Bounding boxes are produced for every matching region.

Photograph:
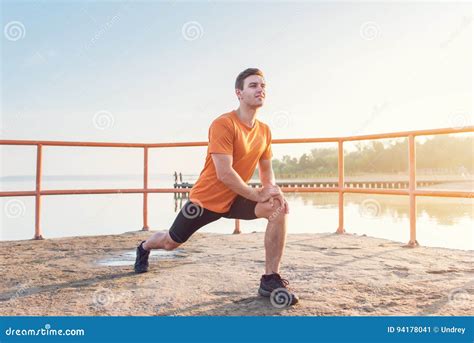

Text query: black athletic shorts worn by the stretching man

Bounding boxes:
[170,195,257,243]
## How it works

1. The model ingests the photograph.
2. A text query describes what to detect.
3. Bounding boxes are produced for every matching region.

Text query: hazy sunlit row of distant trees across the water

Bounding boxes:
[262,135,474,178]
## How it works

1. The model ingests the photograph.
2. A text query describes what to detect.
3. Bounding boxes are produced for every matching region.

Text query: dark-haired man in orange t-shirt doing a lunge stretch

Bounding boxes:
[135,68,298,305]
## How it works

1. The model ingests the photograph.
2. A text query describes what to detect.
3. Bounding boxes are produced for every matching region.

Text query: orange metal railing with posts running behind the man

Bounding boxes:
[0,126,474,247]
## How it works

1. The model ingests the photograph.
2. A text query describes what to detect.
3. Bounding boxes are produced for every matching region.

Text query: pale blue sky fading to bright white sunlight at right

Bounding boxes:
[0,1,473,175]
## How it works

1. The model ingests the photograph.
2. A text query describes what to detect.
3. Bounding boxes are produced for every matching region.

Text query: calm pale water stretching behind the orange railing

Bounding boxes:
[0,174,474,250]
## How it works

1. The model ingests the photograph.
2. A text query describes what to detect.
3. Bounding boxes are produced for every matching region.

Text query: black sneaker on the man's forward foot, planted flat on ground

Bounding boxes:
[258,273,299,308]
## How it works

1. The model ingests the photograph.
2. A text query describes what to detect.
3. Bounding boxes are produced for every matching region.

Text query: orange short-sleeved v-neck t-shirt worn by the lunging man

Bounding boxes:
[189,111,273,213]
